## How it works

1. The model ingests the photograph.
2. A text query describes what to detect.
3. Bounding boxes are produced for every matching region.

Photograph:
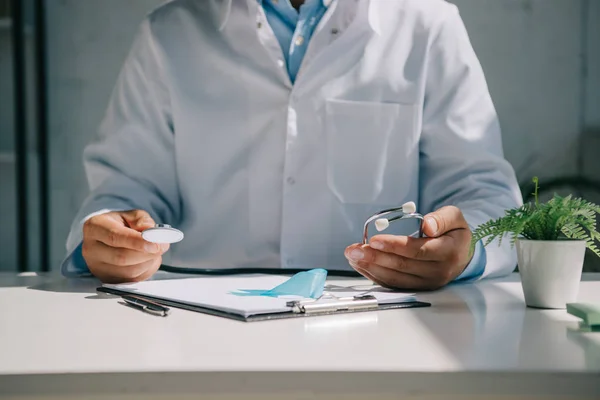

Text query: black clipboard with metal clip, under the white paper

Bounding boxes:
[97,286,431,322]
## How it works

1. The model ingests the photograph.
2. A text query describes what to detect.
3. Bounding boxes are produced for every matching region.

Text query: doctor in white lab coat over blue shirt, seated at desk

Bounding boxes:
[63,0,520,289]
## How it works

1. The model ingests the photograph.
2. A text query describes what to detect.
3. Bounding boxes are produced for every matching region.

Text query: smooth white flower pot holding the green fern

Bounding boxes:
[517,239,586,308]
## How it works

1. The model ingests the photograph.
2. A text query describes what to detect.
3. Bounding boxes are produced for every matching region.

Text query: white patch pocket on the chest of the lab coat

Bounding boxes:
[325,100,414,204]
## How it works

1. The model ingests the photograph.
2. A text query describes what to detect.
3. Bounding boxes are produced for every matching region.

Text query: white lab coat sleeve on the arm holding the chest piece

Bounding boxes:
[62,18,180,275]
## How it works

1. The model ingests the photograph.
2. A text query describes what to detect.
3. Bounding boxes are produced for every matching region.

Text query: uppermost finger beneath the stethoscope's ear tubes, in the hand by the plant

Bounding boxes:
[369,235,455,261]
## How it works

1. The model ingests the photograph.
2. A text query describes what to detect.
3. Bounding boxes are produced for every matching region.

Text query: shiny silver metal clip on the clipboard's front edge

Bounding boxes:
[286,293,379,314]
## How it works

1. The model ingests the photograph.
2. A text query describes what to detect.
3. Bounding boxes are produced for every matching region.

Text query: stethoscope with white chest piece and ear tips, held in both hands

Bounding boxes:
[142,201,423,277]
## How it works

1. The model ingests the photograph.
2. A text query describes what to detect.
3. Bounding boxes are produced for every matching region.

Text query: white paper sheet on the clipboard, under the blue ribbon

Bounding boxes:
[104,275,414,317]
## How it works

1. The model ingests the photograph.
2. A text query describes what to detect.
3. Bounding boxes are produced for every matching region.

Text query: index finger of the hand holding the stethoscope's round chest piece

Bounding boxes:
[84,215,161,254]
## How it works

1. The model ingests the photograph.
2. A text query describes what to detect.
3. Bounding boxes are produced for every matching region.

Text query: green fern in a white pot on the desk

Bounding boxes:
[472,178,600,308]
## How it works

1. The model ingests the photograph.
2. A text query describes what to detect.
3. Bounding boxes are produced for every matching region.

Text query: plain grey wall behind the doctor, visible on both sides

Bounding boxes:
[0,0,600,272]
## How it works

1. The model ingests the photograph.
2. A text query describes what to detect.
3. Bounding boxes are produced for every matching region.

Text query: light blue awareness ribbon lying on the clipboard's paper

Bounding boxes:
[231,268,327,299]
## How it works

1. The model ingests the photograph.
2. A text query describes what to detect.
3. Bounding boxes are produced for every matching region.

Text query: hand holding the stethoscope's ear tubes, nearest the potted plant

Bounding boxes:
[344,206,471,290]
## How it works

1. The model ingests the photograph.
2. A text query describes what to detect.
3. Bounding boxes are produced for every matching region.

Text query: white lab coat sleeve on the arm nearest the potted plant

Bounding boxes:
[420,5,522,280]
